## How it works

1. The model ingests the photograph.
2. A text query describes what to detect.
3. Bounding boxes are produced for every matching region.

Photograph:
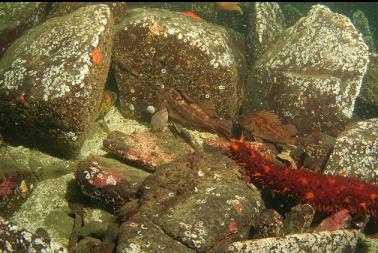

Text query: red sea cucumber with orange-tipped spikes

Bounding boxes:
[230,141,378,219]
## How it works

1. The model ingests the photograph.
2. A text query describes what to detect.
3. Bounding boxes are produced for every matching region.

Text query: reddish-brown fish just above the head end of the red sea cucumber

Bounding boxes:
[238,111,297,145]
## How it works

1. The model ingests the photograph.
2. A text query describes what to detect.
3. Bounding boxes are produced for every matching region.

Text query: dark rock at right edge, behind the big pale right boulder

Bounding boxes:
[354,54,378,119]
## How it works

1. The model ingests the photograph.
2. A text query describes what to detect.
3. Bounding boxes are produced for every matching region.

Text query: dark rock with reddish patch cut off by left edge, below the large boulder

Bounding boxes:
[0,170,36,217]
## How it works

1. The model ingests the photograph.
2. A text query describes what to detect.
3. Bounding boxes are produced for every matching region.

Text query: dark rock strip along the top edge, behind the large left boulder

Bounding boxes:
[47,2,127,24]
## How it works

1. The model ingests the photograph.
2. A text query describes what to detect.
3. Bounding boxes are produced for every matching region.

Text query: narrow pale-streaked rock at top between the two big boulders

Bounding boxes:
[248,2,285,59]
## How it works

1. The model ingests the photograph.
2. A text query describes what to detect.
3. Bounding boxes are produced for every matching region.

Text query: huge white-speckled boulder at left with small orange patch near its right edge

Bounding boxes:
[0,5,113,157]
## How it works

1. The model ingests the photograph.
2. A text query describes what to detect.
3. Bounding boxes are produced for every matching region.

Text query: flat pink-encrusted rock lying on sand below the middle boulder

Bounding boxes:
[103,131,192,171]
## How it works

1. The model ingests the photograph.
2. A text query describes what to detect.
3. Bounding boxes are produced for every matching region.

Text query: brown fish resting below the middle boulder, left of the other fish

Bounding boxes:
[163,88,232,138]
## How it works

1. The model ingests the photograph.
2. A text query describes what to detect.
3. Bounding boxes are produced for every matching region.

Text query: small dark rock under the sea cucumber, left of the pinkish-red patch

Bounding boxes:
[283,204,315,234]
